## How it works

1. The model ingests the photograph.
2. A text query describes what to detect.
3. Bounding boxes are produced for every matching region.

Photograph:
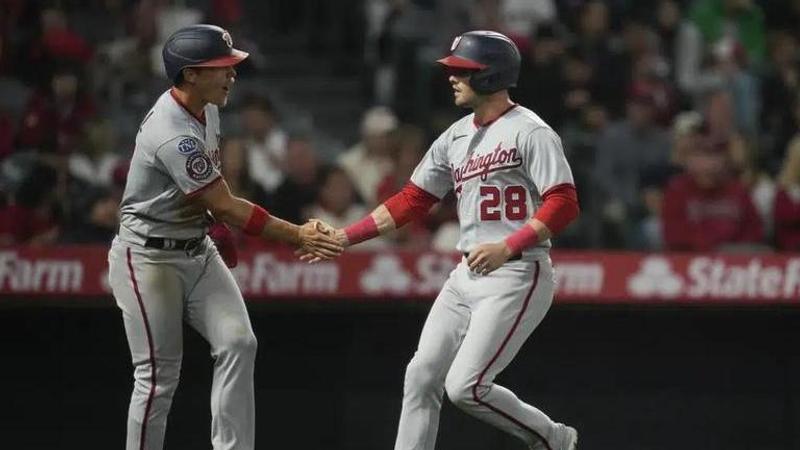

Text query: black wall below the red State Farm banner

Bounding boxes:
[0,299,800,450]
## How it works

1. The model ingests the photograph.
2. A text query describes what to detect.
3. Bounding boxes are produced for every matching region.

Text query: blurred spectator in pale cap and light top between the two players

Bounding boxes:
[338,106,398,206]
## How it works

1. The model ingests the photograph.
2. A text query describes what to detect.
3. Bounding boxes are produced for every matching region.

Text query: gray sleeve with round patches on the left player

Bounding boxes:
[155,136,221,195]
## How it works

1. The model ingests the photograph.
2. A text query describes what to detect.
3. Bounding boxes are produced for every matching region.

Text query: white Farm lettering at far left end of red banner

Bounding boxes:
[0,251,83,293]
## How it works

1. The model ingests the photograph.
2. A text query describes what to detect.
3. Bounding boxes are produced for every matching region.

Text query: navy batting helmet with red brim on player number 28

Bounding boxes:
[436,31,521,94]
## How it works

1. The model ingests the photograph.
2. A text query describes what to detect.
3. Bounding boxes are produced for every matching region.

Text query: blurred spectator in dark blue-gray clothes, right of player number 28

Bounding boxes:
[593,83,670,246]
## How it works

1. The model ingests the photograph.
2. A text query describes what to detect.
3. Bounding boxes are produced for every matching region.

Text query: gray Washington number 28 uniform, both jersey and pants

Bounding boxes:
[395,105,575,450]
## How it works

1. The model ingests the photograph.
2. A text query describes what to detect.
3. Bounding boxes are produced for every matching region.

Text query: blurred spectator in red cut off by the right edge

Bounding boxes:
[774,130,800,252]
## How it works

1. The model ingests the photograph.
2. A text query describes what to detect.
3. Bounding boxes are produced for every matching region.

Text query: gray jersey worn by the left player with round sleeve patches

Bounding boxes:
[120,90,220,239]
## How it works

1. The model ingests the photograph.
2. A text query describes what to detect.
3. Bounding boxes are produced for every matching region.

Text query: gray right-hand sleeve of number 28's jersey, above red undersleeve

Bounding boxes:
[522,128,575,194]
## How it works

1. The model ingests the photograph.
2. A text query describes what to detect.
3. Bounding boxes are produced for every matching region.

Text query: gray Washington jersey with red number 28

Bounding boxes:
[411,105,574,256]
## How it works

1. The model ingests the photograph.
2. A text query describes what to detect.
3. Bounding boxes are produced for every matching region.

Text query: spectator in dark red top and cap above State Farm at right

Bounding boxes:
[662,142,764,251]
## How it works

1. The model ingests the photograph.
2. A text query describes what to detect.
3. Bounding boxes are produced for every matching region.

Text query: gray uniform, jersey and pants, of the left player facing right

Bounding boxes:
[108,91,257,450]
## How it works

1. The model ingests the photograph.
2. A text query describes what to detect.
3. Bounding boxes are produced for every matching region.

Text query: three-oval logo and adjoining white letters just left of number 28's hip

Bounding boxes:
[360,254,456,295]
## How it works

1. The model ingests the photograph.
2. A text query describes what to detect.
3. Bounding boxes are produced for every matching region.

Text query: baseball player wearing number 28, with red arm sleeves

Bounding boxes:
[303,31,578,450]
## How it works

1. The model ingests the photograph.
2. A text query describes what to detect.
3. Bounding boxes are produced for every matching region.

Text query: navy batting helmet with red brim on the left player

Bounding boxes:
[161,24,248,82]
